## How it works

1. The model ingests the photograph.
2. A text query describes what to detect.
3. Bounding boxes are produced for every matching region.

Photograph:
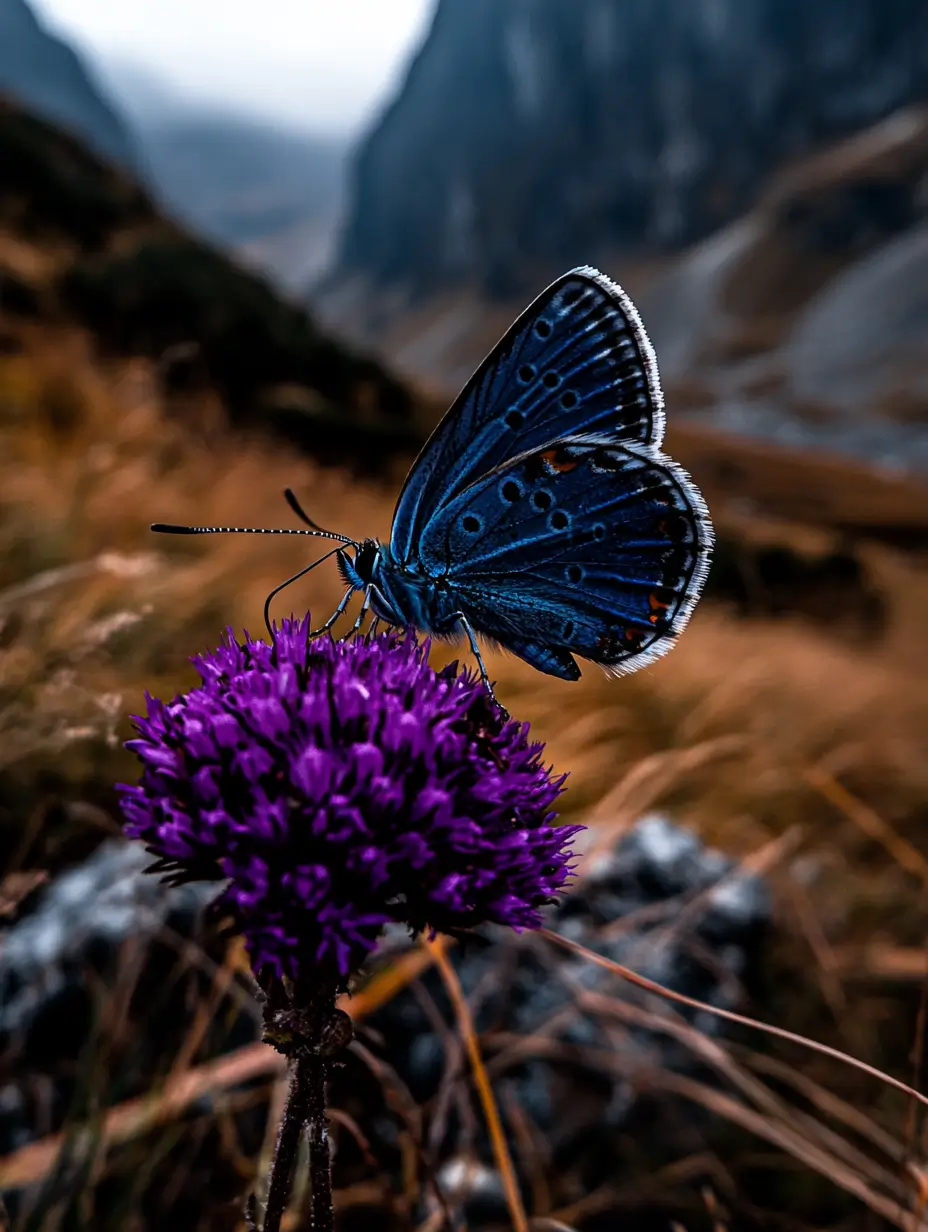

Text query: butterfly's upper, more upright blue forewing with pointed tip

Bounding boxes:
[391,266,664,564]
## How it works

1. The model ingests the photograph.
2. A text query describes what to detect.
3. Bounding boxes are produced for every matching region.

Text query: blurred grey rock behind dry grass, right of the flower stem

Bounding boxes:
[334,814,770,1227]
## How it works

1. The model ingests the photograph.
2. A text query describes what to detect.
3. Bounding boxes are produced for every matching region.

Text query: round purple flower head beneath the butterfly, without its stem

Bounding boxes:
[120,618,582,986]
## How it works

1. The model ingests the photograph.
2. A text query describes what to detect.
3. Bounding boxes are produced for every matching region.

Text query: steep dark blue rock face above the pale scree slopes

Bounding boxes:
[338,0,928,297]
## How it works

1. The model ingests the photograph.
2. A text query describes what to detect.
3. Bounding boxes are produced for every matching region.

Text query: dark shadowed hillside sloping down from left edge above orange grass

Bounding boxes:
[0,100,418,466]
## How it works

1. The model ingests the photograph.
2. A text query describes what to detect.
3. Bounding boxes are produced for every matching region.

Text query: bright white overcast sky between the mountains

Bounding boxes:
[32,0,434,132]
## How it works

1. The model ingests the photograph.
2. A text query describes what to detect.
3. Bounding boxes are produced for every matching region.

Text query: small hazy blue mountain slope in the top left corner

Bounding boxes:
[0,0,137,168]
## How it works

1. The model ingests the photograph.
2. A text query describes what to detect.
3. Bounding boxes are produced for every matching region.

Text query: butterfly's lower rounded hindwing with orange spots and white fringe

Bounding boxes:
[420,439,712,679]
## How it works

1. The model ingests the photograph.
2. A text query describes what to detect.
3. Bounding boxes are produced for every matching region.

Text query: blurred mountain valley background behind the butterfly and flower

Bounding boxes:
[0,0,928,1232]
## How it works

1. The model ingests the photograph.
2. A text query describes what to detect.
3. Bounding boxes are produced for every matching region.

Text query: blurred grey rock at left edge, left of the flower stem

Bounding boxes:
[0,841,256,1177]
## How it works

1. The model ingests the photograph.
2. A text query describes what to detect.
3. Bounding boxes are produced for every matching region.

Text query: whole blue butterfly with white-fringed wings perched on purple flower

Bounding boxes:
[152,266,714,714]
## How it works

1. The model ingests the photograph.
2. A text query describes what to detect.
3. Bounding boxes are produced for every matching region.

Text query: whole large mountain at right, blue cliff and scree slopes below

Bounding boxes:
[312,0,928,476]
